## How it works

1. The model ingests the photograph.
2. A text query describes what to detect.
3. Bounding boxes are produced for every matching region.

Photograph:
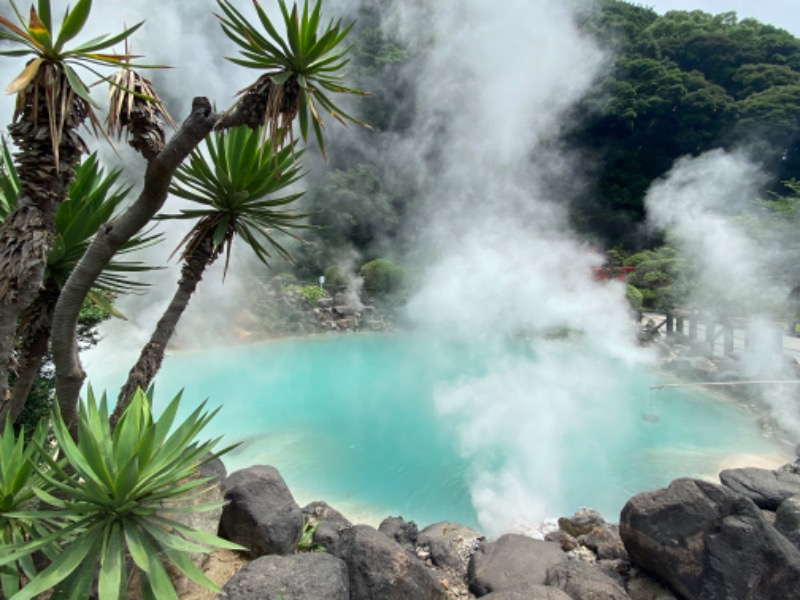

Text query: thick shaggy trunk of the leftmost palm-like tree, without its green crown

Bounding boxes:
[0,64,86,412]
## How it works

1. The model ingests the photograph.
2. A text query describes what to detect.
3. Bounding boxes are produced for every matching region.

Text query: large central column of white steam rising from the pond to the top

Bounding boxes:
[391,0,652,535]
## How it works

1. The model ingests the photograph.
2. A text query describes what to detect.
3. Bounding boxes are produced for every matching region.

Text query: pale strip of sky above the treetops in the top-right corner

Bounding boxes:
[642,0,800,36]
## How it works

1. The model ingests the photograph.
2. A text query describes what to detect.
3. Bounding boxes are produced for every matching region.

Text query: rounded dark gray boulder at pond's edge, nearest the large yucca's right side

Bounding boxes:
[219,466,303,556]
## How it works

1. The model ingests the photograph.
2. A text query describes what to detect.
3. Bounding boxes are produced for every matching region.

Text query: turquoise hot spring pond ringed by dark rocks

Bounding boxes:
[90,335,776,531]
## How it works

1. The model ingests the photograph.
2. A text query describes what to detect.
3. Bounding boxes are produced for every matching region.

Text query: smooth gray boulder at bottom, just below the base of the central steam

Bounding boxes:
[467,533,567,596]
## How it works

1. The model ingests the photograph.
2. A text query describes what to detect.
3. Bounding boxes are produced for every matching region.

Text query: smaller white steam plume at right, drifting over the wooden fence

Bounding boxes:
[645,150,800,435]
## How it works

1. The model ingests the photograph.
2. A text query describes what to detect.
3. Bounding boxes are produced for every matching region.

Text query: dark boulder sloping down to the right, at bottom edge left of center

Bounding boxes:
[335,525,447,600]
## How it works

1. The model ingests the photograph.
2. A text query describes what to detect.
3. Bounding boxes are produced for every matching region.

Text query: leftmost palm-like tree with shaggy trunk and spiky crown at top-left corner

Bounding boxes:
[0,0,169,408]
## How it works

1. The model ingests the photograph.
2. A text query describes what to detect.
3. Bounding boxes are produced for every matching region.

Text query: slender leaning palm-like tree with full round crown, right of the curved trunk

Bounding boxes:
[112,126,311,423]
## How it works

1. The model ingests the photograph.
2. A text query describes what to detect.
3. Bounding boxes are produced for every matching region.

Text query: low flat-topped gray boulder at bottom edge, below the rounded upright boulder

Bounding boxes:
[222,552,350,600]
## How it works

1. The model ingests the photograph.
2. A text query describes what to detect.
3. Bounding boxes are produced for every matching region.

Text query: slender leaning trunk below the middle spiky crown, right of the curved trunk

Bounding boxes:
[111,229,217,428]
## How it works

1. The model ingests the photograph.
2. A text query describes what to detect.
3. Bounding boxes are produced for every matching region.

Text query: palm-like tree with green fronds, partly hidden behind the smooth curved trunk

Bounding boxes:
[0,142,161,422]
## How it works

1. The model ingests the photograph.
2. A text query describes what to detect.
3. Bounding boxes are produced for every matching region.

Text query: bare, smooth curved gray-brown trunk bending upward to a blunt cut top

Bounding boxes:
[52,97,219,424]
